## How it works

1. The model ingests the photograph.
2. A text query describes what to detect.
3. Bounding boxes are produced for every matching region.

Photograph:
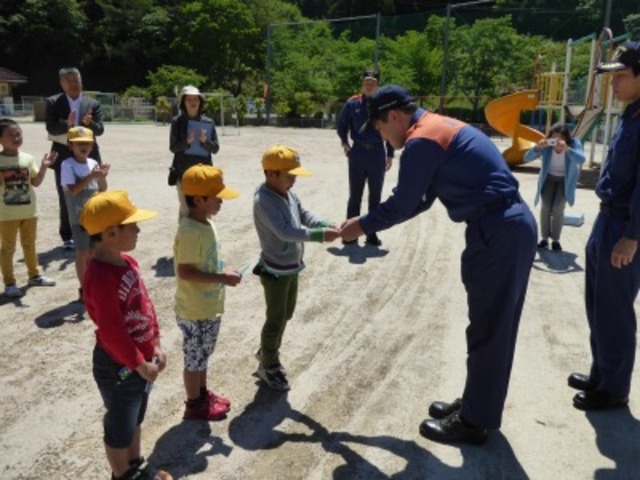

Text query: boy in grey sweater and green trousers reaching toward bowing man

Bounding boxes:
[253,145,340,390]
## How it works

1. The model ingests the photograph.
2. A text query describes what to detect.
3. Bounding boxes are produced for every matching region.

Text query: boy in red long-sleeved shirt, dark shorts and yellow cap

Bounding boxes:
[80,190,171,480]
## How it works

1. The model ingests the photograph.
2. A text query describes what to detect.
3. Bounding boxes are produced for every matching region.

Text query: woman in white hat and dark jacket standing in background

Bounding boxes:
[169,85,220,218]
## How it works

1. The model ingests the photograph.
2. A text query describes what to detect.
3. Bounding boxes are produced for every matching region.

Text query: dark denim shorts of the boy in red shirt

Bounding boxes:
[93,345,149,448]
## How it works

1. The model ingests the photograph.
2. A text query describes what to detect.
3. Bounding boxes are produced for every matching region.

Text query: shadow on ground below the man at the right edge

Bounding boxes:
[585,408,640,480]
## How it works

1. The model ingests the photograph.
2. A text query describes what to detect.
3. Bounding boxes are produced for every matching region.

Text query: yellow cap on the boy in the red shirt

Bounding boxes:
[80,190,158,235]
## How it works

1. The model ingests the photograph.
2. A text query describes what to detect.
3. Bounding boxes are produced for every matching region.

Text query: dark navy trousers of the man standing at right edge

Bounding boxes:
[585,213,640,397]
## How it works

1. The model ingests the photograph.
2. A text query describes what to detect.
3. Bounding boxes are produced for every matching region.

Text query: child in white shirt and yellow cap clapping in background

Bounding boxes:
[60,127,109,302]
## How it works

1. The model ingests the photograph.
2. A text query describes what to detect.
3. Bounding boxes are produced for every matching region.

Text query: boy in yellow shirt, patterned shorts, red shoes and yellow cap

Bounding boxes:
[173,164,242,420]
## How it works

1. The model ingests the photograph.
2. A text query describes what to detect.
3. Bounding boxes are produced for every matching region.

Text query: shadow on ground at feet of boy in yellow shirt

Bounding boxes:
[148,420,233,478]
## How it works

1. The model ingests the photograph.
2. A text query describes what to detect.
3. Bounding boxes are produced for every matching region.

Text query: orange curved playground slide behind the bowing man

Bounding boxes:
[484,90,544,166]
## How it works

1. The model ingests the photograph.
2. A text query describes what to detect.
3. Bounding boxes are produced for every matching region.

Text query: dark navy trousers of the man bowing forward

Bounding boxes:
[461,201,537,429]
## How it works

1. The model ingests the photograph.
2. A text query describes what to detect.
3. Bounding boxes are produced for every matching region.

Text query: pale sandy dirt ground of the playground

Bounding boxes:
[0,123,640,480]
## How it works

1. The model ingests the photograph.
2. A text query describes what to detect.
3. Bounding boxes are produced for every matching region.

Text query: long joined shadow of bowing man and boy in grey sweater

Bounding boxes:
[229,385,528,480]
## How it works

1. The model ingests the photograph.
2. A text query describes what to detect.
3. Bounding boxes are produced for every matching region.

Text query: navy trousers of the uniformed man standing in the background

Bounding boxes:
[347,142,386,218]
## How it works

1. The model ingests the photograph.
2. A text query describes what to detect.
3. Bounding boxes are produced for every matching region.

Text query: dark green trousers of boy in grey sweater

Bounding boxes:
[260,273,298,368]
